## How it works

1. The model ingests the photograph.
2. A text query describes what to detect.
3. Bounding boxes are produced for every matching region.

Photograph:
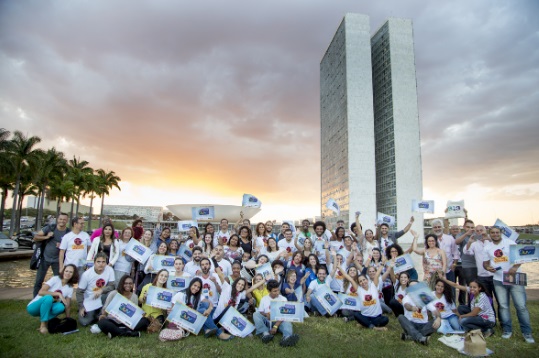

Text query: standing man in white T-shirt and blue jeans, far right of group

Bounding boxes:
[483,226,535,343]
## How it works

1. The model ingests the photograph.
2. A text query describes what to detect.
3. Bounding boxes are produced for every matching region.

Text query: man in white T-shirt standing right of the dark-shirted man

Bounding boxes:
[58,218,90,277]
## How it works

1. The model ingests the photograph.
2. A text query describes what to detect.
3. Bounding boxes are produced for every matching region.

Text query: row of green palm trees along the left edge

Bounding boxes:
[0,128,121,236]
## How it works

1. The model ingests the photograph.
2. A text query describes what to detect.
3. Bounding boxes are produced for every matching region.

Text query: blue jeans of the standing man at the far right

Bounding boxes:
[494,280,532,335]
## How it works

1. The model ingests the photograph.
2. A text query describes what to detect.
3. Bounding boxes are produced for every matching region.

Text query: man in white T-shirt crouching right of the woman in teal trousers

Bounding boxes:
[77,252,114,326]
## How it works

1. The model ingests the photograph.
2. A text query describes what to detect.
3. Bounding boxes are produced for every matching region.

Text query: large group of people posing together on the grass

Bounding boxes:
[28,214,534,347]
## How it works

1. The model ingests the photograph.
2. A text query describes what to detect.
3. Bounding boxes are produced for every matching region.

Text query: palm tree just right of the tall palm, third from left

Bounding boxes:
[35,147,67,231]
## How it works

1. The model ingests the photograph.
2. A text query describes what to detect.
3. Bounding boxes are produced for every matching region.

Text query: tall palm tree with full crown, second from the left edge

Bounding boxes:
[7,131,41,236]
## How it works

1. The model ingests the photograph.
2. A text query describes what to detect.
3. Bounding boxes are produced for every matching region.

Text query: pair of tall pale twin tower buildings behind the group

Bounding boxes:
[320,14,423,241]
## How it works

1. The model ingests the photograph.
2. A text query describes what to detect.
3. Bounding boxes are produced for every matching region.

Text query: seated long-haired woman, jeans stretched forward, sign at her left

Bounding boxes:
[170,277,234,341]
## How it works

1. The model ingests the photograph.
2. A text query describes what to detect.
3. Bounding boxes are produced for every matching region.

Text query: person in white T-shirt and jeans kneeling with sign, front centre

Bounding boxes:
[253,280,299,347]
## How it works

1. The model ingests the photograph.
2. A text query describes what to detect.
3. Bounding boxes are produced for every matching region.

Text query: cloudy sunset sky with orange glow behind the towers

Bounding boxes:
[0,0,539,225]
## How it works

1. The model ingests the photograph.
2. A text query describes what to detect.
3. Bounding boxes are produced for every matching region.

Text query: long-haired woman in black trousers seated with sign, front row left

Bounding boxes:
[97,275,150,339]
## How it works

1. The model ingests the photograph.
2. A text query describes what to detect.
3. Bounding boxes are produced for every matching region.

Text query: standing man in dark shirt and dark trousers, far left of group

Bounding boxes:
[33,213,71,297]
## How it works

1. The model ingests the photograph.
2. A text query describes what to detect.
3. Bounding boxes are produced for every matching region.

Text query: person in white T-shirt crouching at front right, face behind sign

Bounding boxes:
[397,281,442,345]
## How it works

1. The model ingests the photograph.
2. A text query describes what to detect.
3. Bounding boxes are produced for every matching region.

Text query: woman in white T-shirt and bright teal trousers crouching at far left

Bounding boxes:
[26,264,79,334]
